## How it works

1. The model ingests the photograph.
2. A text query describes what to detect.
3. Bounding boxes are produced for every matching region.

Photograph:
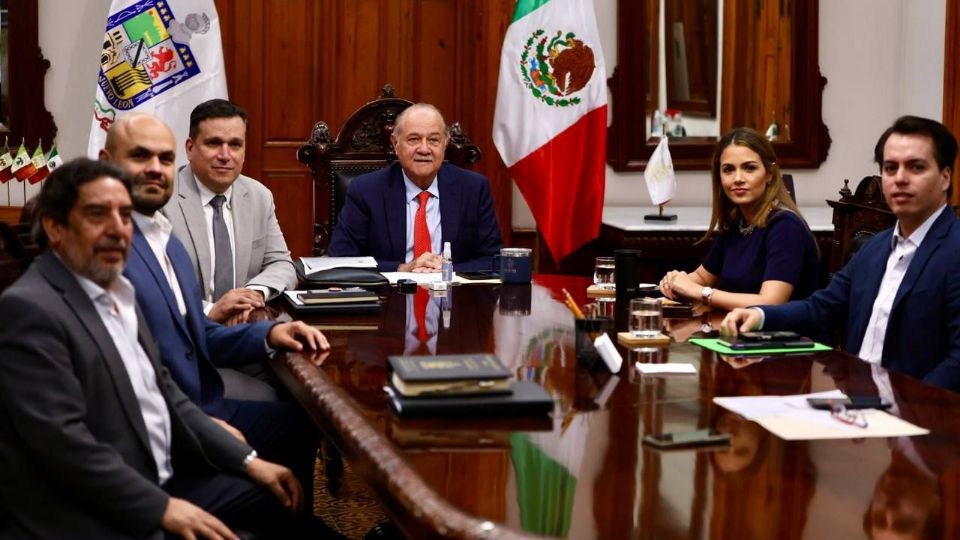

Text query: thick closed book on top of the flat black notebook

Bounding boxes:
[388,354,510,396]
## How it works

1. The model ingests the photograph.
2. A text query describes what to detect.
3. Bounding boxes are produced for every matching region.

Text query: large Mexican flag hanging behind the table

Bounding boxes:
[493,0,607,261]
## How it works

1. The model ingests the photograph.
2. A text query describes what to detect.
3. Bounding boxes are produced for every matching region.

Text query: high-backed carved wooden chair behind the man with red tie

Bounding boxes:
[297,84,480,255]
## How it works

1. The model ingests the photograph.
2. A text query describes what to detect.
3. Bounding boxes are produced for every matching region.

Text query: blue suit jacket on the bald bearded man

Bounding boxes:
[123,224,272,419]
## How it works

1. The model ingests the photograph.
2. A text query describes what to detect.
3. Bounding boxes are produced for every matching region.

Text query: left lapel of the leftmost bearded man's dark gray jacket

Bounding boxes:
[38,250,151,452]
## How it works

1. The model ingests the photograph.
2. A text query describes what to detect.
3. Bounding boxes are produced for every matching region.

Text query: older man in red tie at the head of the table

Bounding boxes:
[329,103,503,272]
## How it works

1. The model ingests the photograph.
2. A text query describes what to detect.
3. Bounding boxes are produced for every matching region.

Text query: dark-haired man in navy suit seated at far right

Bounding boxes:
[723,116,960,392]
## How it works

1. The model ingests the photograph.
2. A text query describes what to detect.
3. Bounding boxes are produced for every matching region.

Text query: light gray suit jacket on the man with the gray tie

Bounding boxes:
[162,165,297,301]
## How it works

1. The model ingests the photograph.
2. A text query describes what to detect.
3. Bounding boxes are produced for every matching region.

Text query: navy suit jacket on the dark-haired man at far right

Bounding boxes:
[763,207,960,392]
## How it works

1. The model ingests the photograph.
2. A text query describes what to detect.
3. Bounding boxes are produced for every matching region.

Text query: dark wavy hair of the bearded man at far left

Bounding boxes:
[33,158,130,247]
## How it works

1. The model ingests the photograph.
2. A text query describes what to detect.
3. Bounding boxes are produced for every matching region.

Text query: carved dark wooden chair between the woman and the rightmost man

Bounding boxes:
[827,176,897,277]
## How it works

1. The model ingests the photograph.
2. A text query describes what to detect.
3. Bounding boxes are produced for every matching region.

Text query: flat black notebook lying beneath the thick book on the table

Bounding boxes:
[385,381,553,418]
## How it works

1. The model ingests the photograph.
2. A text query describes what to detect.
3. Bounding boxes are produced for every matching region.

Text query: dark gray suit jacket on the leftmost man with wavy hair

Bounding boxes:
[0,251,250,539]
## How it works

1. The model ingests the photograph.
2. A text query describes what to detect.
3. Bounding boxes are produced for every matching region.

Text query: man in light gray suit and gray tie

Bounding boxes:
[163,99,297,324]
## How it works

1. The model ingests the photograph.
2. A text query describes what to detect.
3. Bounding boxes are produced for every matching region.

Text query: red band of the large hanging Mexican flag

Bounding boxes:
[510,105,607,262]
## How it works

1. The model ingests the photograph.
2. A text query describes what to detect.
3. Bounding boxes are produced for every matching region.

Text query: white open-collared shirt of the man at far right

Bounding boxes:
[857,205,946,364]
